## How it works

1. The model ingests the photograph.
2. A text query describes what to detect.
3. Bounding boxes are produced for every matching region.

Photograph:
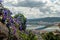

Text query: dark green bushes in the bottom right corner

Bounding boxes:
[42,32,60,40]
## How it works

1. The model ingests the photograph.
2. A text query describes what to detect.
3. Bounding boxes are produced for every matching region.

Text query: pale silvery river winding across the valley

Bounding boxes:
[26,25,60,31]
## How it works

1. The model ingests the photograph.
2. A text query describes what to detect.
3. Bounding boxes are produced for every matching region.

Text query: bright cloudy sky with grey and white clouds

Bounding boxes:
[3,0,60,19]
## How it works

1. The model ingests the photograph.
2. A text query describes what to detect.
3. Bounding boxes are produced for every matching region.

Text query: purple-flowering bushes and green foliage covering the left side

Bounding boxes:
[0,3,37,40]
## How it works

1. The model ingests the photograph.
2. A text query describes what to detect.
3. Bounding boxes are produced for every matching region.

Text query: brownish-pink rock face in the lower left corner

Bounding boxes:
[0,22,8,40]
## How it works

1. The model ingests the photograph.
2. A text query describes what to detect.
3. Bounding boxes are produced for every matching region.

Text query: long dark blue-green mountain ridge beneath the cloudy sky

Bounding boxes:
[27,17,60,22]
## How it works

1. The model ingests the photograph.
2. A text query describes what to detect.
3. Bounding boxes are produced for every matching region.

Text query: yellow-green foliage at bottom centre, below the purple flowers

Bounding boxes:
[17,30,38,40]
